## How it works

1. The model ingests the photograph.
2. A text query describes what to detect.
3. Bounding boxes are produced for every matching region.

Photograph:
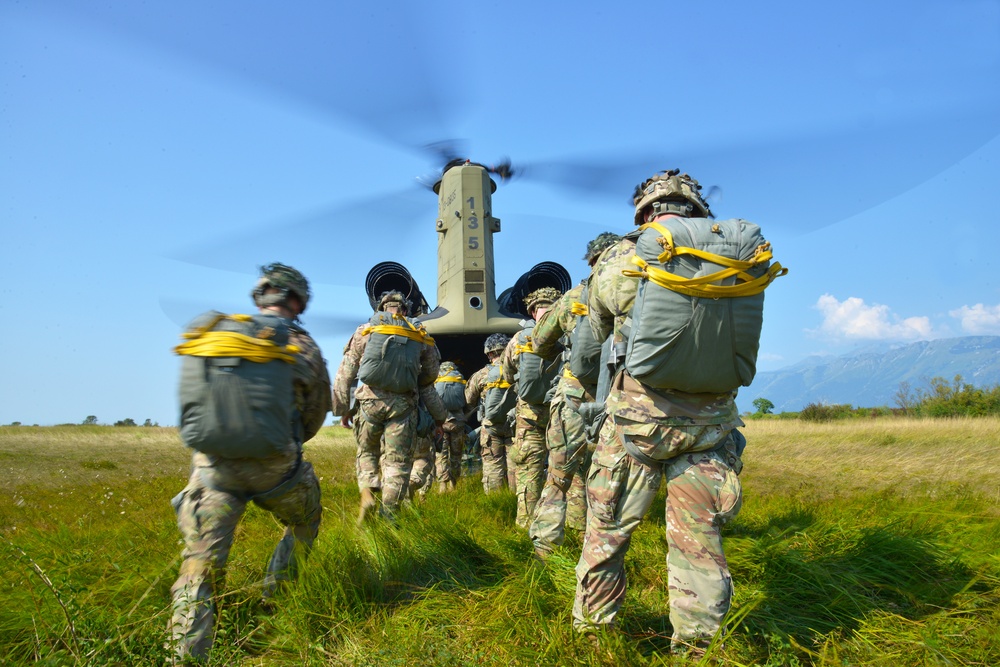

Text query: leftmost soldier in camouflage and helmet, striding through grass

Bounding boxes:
[170,264,330,662]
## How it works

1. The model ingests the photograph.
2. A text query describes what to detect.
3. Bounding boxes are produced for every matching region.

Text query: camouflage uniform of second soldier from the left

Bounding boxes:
[333,323,448,515]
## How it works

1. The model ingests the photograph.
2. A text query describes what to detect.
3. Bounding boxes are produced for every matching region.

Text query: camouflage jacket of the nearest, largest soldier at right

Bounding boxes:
[587,232,743,427]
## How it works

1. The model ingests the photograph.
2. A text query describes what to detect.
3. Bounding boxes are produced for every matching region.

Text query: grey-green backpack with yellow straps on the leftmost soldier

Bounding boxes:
[174,311,299,458]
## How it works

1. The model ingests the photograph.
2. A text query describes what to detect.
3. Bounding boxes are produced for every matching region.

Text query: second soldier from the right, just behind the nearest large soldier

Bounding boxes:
[528,232,621,559]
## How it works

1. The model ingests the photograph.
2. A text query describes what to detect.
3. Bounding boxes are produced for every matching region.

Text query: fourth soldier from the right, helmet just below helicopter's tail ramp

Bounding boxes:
[465,334,513,493]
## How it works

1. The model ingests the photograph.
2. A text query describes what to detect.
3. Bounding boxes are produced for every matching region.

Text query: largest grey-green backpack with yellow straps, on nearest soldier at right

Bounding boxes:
[624,217,788,394]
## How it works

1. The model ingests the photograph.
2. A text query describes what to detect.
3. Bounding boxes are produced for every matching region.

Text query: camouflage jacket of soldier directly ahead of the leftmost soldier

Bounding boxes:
[333,322,448,422]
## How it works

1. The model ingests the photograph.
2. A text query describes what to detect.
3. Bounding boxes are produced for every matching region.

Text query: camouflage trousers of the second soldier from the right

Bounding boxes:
[528,392,587,552]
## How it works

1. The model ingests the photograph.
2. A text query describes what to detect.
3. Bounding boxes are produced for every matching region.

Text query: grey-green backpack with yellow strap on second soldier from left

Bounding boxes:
[358,311,434,394]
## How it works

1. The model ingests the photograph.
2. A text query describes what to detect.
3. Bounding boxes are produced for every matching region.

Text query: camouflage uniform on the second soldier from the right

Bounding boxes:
[528,283,596,553]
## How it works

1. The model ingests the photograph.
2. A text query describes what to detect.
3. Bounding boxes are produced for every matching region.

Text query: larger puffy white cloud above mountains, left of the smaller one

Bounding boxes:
[816,294,931,341]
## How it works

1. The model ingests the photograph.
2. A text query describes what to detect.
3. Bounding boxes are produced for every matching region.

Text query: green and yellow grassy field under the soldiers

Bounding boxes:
[0,419,1000,667]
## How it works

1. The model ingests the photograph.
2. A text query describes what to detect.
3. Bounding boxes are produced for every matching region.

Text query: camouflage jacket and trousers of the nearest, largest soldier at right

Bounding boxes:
[573,238,742,650]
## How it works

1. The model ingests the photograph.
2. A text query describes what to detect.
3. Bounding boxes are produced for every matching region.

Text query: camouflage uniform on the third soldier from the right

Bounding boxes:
[500,320,549,528]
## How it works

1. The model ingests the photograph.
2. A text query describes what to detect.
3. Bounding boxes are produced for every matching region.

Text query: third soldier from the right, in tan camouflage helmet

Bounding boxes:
[500,287,562,528]
